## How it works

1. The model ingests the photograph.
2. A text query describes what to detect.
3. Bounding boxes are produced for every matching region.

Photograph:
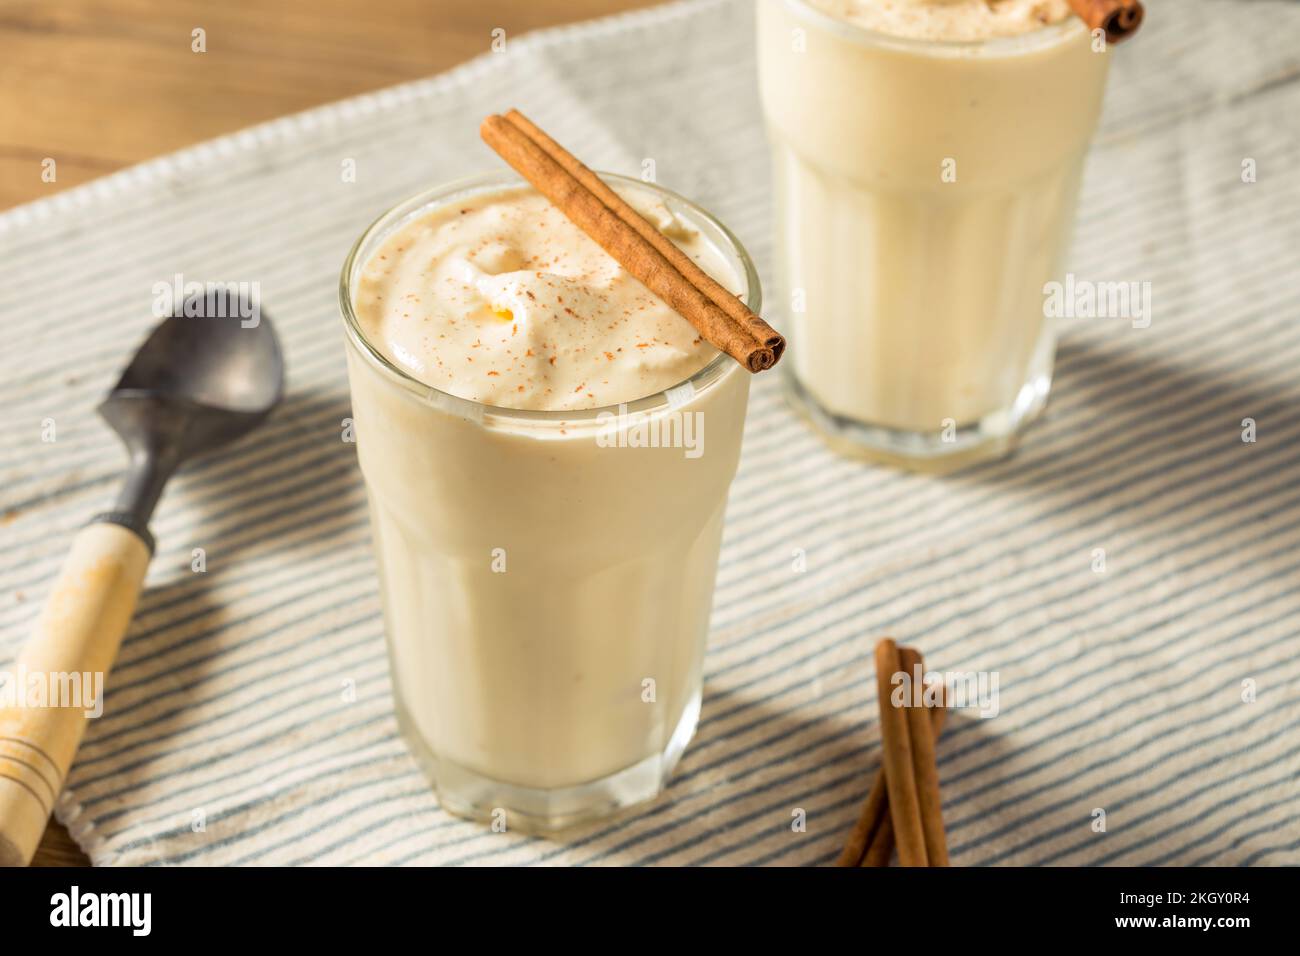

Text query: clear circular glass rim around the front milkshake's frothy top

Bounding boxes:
[338,170,763,424]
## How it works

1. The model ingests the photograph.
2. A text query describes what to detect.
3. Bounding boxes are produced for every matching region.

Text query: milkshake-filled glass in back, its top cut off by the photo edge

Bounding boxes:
[758,0,1109,464]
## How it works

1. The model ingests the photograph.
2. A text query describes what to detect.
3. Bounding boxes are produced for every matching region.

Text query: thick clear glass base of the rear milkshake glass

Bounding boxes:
[781,367,1052,472]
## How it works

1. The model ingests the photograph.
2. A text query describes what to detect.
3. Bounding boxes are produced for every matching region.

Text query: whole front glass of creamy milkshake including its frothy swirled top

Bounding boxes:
[341,176,759,830]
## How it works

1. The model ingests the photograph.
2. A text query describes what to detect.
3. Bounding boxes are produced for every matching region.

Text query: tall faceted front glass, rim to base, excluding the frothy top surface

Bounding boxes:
[339,174,761,831]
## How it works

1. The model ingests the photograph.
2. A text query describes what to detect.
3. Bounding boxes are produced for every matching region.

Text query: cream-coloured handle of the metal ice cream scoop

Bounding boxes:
[0,522,150,866]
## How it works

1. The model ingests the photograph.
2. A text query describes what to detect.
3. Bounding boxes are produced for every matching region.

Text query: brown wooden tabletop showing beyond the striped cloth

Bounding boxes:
[0,0,655,866]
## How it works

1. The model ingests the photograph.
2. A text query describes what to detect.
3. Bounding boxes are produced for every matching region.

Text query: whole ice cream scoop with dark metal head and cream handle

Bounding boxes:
[0,287,285,866]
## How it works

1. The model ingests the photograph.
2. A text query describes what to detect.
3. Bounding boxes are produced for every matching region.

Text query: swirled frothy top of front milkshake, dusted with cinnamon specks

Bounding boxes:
[358,117,764,410]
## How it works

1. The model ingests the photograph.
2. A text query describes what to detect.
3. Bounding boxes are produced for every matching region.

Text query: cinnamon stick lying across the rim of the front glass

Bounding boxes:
[478,109,785,372]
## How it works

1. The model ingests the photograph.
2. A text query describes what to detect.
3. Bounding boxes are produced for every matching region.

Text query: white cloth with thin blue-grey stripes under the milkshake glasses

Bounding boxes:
[0,0,1300,865]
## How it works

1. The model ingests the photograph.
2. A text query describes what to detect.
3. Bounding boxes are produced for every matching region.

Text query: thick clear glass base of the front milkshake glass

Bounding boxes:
[397,691,701,834]
